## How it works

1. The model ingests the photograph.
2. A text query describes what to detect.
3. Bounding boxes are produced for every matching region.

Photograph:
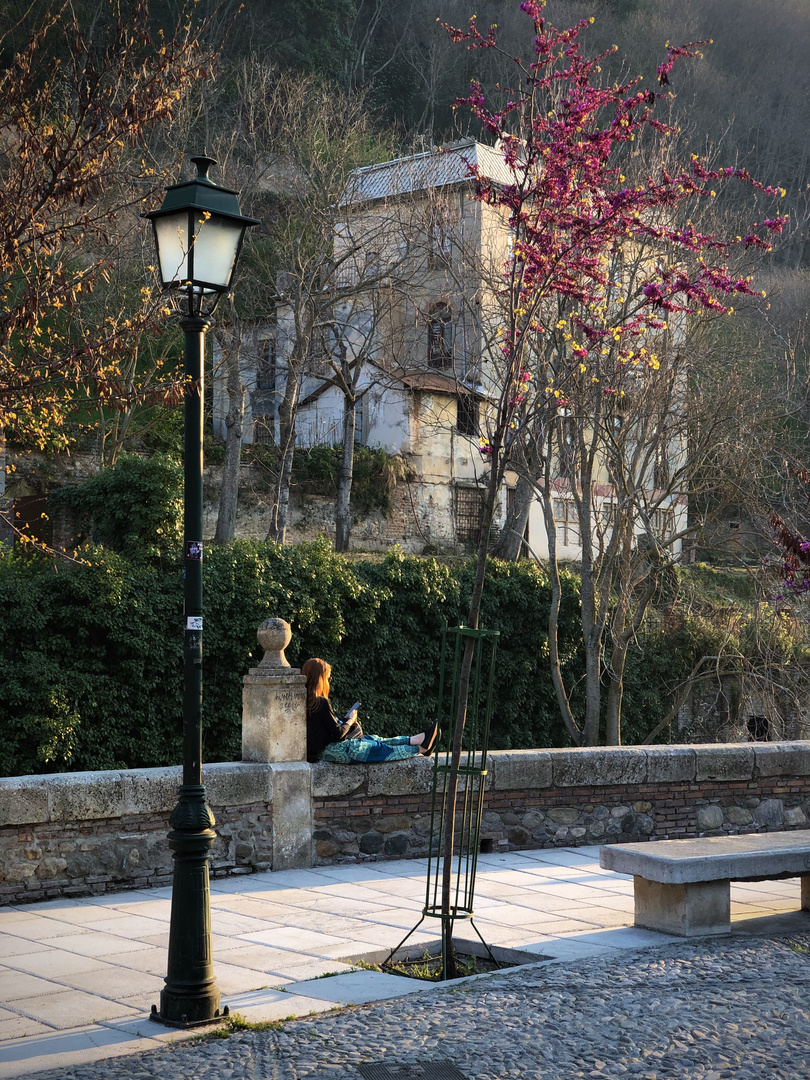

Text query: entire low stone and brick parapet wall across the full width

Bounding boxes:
[0,742,810,904]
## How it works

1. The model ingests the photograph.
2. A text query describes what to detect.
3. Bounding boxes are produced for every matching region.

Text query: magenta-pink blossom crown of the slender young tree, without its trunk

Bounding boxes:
[443,0,785,453]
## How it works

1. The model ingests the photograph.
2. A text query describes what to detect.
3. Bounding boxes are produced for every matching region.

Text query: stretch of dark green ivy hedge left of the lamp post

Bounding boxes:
[0,549,183,775]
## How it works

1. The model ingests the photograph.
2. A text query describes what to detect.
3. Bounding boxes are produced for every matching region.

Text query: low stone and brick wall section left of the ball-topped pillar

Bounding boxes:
[0,765,272,904]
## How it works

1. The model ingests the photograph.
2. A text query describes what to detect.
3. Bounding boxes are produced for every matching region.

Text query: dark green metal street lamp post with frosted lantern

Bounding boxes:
[144,157,258,1027]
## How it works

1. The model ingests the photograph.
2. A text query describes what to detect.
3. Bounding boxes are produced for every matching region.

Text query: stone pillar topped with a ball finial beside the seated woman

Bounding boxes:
[242,619,312,870]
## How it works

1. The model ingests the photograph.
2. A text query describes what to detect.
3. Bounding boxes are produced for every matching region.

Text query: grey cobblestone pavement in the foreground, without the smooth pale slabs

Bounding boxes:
[30,930,810,1080]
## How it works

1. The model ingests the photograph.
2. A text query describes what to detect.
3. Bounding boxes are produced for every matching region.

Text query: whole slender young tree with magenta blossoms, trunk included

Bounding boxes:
[434,0,785,967]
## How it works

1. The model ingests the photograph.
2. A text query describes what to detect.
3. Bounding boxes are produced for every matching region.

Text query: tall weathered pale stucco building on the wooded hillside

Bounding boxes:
[214,140,686,559]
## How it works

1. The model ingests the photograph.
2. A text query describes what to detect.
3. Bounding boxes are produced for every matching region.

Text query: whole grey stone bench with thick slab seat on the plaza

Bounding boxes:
[599,831,810,936]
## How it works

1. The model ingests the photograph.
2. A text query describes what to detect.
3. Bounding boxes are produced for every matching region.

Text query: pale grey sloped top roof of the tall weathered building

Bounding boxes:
[341,139,514,205]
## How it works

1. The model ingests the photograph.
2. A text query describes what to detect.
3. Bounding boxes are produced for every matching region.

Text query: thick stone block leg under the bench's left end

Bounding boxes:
[633,877,734,937]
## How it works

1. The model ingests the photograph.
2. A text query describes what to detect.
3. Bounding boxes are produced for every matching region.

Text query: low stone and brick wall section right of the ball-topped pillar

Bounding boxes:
[313,742,810,863]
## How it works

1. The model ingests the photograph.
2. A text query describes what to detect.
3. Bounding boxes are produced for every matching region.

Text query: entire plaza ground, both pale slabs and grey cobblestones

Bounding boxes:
[0,848,810,1080]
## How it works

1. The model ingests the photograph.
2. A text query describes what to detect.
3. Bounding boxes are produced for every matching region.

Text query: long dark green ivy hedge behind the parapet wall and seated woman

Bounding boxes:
[0,540,579,775]
